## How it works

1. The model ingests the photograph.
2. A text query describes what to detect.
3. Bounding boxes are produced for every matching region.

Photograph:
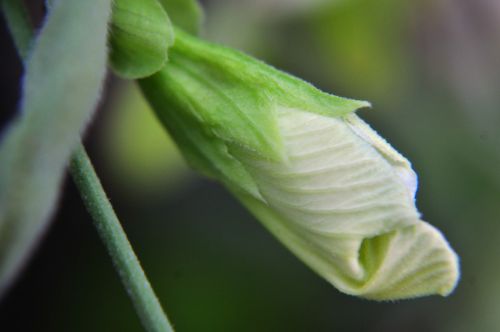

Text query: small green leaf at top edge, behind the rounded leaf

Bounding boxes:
[160,0,203,34]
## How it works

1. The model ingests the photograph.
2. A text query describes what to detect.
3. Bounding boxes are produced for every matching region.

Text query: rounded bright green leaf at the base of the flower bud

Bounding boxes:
[109,0,174,79]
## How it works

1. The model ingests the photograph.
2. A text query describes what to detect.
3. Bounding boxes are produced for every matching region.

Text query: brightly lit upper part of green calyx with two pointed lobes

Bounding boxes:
[158,30,368,160]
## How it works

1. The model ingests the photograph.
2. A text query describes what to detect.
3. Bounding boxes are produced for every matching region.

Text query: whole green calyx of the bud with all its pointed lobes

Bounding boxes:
[140,29,367,198]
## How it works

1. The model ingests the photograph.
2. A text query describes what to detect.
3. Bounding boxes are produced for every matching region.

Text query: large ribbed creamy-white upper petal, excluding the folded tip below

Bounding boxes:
[236,109,418,236]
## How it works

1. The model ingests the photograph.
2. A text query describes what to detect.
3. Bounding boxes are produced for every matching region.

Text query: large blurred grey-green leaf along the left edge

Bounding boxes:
[0,0,111,293]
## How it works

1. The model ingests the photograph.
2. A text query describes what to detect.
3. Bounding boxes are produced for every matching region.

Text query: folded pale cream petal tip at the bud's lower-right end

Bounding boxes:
[352,221,459,300]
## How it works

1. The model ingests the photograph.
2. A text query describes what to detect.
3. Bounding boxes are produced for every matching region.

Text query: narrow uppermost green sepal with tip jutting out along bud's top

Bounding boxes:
[172,29,370,117]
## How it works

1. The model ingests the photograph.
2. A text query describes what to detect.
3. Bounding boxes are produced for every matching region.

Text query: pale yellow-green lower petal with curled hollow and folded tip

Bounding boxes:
[235,193,459,300]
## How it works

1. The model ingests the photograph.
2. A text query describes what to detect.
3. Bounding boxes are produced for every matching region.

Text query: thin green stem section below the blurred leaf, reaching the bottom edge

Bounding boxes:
[70,146,173,331]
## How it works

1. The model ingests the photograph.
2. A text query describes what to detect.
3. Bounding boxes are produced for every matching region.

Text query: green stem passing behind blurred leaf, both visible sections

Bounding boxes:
[0,0,173,332]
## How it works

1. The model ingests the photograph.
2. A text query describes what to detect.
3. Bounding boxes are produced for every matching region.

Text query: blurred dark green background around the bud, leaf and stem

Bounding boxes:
[0,0,500,332]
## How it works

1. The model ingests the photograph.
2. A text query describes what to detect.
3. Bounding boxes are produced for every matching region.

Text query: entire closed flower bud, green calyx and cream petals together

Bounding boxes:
[140,31,459,300]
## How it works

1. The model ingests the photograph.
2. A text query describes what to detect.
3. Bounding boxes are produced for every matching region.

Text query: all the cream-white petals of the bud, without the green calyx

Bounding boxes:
[232,109,458,300]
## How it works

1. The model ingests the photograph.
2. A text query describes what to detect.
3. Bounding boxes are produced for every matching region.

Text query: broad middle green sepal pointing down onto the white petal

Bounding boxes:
[149,30,283,160]
